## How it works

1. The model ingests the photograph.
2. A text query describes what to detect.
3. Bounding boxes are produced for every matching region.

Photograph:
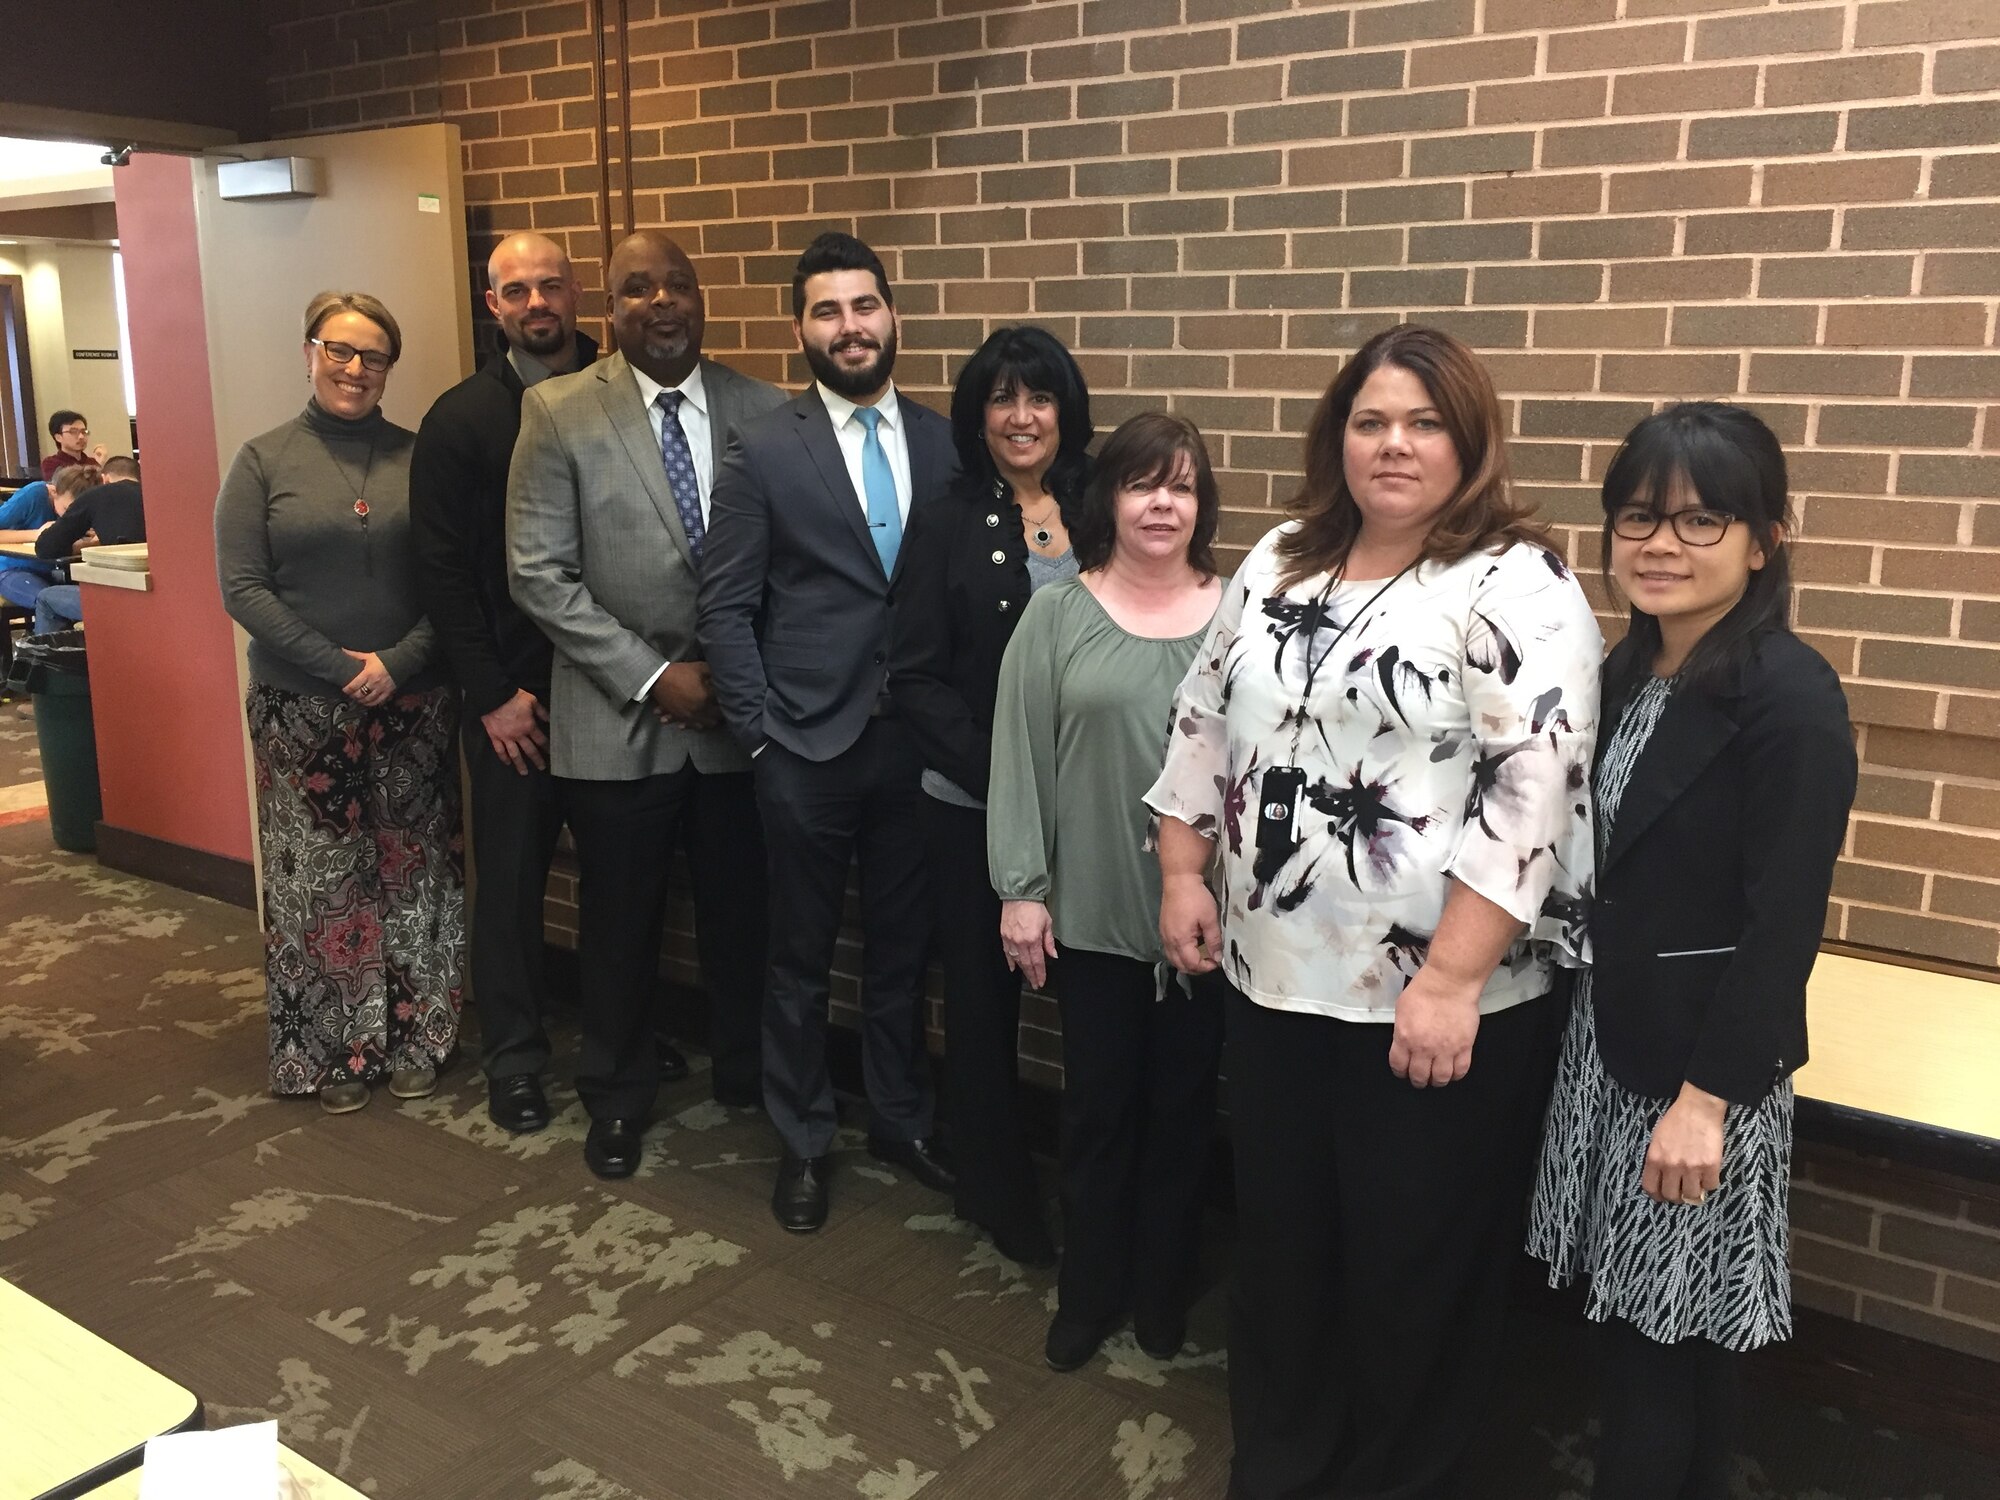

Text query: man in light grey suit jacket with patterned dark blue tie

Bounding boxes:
[506,230,784,1178]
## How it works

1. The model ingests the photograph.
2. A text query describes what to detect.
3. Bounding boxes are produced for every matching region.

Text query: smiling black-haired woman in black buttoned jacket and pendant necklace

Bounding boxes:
[888,328,1092,1266]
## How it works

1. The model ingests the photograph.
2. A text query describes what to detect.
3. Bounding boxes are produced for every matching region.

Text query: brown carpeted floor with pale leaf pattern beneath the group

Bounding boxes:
[0,824,2000,1500]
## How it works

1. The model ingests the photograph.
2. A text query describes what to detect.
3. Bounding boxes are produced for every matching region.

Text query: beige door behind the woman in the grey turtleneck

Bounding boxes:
[194,124,472,458]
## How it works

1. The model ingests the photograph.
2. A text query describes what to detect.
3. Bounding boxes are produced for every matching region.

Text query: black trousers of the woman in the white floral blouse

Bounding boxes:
[1228,988,1562,1500]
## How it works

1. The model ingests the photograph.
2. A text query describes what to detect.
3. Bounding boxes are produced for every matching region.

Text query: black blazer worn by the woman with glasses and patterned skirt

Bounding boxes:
[1590,630,1856,1104]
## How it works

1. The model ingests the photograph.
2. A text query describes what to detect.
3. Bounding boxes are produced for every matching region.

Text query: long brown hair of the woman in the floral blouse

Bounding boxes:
[1278,322,1546,588]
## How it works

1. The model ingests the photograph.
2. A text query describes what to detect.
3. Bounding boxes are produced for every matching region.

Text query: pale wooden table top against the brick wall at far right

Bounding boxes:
[1796,954,2000,1140]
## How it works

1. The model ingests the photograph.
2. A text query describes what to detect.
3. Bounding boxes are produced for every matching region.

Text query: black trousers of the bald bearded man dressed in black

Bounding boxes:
[464,714,562,1078]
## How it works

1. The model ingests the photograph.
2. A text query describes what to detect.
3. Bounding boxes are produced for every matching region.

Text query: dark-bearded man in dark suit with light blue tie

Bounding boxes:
[700,234,956,1232]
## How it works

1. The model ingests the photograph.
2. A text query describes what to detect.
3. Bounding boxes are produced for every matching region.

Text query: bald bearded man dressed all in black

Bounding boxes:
[410,234,598,1132]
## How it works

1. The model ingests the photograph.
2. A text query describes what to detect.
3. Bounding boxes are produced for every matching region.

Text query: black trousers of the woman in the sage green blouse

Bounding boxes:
[1056,942,1222,1322]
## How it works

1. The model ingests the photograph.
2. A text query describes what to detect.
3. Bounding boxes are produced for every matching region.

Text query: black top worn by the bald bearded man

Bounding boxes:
[410,334,598,718]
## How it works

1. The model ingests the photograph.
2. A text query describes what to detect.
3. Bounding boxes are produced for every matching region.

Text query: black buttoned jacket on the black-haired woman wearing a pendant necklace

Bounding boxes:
[888,486,1032,798]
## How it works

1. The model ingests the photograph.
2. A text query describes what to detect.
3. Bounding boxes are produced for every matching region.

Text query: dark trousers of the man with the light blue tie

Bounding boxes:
[752,718,932,1156]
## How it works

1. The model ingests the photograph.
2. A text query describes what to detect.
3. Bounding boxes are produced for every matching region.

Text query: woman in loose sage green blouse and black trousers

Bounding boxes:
[986,412,1222,1370]
